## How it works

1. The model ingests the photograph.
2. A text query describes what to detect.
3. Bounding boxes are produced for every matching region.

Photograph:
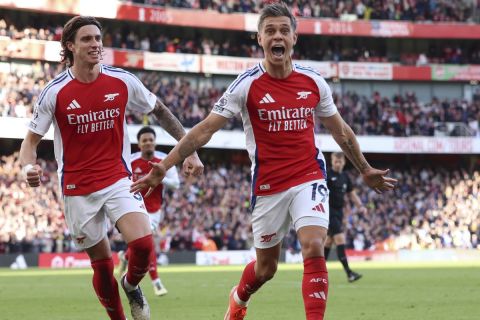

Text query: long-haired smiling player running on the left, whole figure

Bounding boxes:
[20,16,203,320]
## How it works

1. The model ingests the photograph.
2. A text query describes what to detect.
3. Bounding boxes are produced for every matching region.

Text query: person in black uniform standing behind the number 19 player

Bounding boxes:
[325,152,367,282]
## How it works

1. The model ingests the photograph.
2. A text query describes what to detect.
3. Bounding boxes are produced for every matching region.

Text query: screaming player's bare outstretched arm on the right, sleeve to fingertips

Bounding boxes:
[320,112,397,193]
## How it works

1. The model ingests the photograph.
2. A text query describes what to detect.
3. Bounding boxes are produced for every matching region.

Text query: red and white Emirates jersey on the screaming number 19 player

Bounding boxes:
[212,63,337,195]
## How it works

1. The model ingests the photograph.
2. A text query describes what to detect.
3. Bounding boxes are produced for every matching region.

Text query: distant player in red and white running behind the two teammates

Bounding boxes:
[118,127,180,296]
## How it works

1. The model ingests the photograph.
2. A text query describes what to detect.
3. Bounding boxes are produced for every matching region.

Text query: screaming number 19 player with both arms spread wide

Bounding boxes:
[131,3,396,320]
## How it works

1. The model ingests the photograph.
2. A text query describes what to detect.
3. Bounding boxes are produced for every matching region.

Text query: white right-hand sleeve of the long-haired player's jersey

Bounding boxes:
[124,73,157,114]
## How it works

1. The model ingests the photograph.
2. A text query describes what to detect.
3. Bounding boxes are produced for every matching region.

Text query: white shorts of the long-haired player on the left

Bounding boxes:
[64,178,148,249]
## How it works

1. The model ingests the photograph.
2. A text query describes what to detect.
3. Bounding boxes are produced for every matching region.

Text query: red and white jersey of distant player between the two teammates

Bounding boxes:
[132,151,180,213]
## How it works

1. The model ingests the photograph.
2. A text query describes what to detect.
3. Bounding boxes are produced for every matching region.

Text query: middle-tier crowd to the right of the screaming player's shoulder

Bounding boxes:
[330,92,480,137]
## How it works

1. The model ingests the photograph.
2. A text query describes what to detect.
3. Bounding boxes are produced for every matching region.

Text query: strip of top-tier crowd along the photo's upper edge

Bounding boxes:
[122,0,479,22]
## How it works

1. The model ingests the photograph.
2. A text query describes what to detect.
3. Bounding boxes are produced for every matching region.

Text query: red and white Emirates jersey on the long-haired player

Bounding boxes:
[29,65,156,196]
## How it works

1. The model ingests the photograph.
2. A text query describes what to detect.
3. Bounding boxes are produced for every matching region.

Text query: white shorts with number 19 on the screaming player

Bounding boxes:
[252,179,329,249]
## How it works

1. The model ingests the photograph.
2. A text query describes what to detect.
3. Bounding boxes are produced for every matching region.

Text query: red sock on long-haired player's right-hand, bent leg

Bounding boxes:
[127,234,153,286]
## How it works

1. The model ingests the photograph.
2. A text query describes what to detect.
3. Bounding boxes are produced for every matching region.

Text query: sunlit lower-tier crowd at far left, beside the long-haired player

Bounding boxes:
[0,153,67,253]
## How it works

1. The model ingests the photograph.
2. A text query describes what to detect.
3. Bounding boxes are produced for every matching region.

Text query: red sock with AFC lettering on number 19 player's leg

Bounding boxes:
[302,257,328,320]
